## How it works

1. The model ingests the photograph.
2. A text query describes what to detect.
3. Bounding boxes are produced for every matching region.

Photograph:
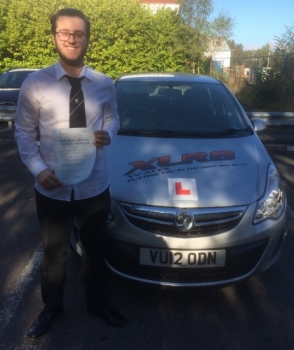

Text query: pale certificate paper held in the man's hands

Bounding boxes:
[53,128,96,185]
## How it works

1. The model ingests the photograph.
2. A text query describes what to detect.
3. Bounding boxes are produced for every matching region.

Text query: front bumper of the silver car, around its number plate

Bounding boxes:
[105,201,287,287]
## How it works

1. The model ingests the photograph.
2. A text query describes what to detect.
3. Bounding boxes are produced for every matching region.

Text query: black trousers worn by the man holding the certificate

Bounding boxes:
[35,189,110,310]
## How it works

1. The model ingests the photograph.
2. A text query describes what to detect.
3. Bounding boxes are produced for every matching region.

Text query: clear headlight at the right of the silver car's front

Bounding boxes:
[254,164,285,224]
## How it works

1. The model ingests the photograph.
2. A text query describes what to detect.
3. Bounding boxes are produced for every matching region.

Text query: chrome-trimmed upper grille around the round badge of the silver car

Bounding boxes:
[120,203,246,237]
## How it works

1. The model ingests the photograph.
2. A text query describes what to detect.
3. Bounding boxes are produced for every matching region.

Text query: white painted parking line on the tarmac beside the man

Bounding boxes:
[0,243,43,337]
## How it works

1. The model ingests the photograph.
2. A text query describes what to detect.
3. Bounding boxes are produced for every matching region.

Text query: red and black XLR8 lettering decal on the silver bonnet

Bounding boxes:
[125,150,235,176]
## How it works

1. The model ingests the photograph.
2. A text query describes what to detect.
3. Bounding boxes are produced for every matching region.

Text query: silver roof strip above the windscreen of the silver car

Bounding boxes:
[116,73,222,84]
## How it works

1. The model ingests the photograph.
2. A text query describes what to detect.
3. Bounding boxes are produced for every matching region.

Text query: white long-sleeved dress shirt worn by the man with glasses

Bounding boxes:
[15,62,119,201]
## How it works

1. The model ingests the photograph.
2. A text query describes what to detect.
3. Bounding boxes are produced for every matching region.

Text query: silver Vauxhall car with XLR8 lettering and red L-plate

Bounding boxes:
[72,73,287,287]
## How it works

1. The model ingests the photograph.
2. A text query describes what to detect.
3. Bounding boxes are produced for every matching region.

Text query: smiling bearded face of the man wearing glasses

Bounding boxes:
[52,16,88,67]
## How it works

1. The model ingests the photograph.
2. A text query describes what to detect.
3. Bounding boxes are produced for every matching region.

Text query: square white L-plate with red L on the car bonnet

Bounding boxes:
[168,179,198,201]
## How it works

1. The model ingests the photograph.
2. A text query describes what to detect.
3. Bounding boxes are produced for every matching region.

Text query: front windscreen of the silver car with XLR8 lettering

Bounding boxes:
[116,80,248,137]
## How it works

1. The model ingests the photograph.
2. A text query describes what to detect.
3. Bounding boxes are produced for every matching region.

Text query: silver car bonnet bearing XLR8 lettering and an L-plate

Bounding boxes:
[106,135,270,208]
